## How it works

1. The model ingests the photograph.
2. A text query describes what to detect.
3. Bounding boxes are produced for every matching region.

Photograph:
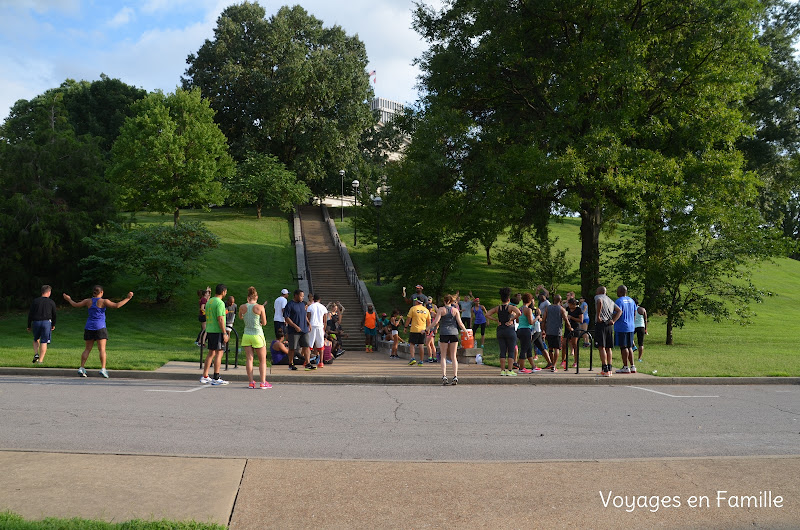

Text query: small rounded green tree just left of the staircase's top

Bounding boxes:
[226,153,311,219]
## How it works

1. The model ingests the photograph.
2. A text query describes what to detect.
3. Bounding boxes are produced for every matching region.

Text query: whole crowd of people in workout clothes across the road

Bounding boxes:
[27,278,648,389]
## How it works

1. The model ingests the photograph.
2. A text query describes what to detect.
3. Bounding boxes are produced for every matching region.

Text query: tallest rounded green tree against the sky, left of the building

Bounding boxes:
[183,2,373,194]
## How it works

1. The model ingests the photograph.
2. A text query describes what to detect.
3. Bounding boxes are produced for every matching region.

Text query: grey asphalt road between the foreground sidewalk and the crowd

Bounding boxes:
[0,377,800,462]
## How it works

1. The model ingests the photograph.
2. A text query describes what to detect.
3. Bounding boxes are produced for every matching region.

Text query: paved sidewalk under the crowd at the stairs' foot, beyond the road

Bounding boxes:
[0,351,800,385]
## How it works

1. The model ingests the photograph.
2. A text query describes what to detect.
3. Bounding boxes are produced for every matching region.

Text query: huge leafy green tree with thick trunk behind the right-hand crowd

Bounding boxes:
[414,0,760,308]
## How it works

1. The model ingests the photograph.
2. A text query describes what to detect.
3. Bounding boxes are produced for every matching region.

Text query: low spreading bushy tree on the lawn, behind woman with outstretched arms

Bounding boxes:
[80,221,219,303]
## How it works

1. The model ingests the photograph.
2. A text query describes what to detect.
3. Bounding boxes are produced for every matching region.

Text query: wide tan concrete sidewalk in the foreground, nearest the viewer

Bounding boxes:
[0,451,800,529]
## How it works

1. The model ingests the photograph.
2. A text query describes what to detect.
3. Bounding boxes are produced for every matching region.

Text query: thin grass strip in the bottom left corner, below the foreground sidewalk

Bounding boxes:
[0,511,225,530]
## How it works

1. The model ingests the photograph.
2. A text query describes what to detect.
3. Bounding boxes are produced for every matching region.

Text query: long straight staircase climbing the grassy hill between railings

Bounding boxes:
[300,206,364,351]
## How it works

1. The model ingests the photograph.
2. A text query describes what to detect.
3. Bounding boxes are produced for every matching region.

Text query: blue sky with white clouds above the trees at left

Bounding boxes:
[0,0,440,120]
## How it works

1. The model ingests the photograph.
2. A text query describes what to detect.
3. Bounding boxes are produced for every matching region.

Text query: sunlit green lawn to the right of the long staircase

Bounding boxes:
[331,209,800,377]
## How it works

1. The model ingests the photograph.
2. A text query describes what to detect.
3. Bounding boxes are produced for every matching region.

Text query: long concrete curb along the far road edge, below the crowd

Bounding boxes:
[0,367,800,386]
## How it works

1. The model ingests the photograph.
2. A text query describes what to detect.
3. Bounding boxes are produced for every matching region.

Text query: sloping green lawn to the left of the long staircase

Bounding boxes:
[0,209,294,370]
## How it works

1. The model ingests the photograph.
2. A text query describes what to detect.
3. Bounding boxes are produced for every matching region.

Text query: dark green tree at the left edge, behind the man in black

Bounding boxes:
[0,90,117,307]
